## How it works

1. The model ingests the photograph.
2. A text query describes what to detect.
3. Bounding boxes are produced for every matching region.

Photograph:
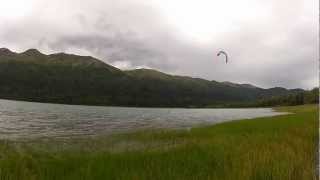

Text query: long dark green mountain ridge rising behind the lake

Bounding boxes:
[0,48,303,107]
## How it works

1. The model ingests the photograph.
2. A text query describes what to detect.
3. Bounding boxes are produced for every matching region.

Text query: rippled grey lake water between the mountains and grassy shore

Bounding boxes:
[0,100,283,139]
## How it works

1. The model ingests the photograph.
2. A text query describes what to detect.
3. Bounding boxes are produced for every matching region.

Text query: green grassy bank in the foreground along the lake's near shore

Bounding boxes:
[0,105,319,180]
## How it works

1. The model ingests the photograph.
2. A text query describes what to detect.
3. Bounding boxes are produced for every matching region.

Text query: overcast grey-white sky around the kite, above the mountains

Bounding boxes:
[0,0,319,88]
